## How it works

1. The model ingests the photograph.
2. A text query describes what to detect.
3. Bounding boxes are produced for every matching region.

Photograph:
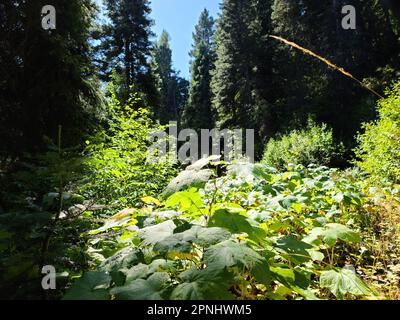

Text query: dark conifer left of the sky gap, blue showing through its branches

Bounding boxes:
[98,0,158,106]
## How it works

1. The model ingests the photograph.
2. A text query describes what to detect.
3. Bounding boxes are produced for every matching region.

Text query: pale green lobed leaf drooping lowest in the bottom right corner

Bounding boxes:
[319,269,371,299]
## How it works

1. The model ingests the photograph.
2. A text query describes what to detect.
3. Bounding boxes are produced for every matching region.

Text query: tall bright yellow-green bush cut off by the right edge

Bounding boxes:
[355,82,400,183]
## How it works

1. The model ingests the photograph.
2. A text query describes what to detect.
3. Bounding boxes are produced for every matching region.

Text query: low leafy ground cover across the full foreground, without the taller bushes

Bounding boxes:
[0,158,400,300]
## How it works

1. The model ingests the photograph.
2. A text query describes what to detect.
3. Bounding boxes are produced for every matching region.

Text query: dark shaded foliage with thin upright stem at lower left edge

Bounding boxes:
[0,134,89,299]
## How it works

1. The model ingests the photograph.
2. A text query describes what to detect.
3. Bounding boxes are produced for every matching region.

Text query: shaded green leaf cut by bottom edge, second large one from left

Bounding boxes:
[110,272,170,300]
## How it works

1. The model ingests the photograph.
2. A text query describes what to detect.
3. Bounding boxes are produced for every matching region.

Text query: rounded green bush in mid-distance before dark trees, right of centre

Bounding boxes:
[263,121,344,169]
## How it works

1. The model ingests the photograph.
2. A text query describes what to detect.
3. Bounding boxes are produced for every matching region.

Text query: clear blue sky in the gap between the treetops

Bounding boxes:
[96,0,221,79]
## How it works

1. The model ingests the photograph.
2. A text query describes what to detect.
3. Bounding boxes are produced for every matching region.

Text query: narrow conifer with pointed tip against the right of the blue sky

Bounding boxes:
[181,9,215,130]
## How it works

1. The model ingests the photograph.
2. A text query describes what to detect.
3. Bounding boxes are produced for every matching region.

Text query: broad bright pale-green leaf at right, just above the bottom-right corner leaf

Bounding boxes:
[304,223,361,247]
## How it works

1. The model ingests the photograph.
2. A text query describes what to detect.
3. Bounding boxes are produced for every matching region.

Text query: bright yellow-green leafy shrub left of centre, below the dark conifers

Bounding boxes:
[81,85,174,206]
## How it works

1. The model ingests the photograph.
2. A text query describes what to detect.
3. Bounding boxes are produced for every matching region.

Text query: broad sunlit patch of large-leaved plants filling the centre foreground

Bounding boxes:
[67,164,374,300]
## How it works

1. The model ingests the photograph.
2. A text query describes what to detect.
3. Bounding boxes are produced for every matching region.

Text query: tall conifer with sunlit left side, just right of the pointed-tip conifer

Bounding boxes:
[211,0,253,128]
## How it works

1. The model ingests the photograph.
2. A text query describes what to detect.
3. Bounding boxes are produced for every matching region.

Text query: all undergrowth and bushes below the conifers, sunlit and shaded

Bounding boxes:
[0,82,400,300]
